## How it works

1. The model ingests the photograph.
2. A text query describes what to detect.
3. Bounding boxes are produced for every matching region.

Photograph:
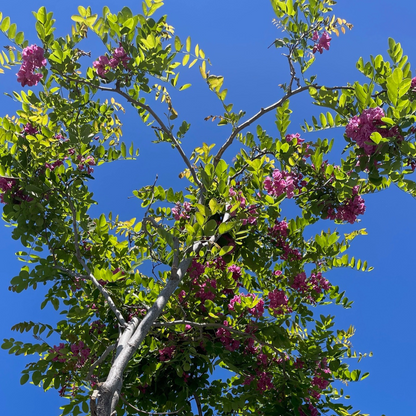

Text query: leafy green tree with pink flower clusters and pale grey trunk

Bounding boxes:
[0,1,415,415]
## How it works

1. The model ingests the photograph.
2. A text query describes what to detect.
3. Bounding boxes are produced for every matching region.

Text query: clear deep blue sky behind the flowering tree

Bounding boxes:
[0,0,416,416]
